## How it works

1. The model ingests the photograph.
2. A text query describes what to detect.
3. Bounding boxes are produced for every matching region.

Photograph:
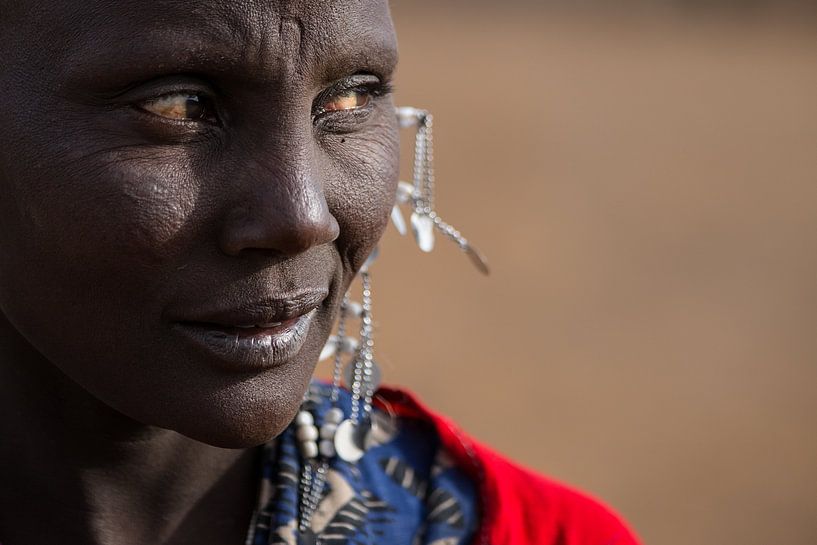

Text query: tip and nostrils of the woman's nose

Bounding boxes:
[219,147,340,256]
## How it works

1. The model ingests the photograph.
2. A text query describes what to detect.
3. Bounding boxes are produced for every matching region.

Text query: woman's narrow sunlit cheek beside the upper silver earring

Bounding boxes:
[326,121,400,271]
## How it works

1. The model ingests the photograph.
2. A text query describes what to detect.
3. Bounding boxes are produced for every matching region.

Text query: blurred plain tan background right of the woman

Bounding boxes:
[326,4,817,545]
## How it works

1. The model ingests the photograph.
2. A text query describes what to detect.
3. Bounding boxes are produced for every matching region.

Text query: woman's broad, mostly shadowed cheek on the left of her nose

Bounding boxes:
[0,147,201,359]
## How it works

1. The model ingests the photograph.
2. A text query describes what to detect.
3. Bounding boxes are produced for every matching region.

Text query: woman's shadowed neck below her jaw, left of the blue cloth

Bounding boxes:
[0,317,257,545]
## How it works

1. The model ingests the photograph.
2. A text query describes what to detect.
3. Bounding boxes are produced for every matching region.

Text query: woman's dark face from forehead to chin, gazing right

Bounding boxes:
[0,0,398,447]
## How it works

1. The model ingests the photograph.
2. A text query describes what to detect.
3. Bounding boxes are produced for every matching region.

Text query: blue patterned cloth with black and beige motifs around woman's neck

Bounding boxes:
[248,383,478,545]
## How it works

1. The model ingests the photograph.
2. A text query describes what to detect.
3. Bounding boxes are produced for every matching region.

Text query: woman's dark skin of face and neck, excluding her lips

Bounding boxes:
[0,0,398,545]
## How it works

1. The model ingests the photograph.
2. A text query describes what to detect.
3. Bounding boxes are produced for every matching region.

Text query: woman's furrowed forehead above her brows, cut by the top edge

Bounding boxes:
[8,0,396,81]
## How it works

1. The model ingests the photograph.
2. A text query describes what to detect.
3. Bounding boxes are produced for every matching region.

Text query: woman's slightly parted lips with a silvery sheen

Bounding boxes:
[173,291,327,372]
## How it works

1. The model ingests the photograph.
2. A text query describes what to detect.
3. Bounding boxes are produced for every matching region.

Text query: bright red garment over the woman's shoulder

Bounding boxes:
[377,388,639,545]
